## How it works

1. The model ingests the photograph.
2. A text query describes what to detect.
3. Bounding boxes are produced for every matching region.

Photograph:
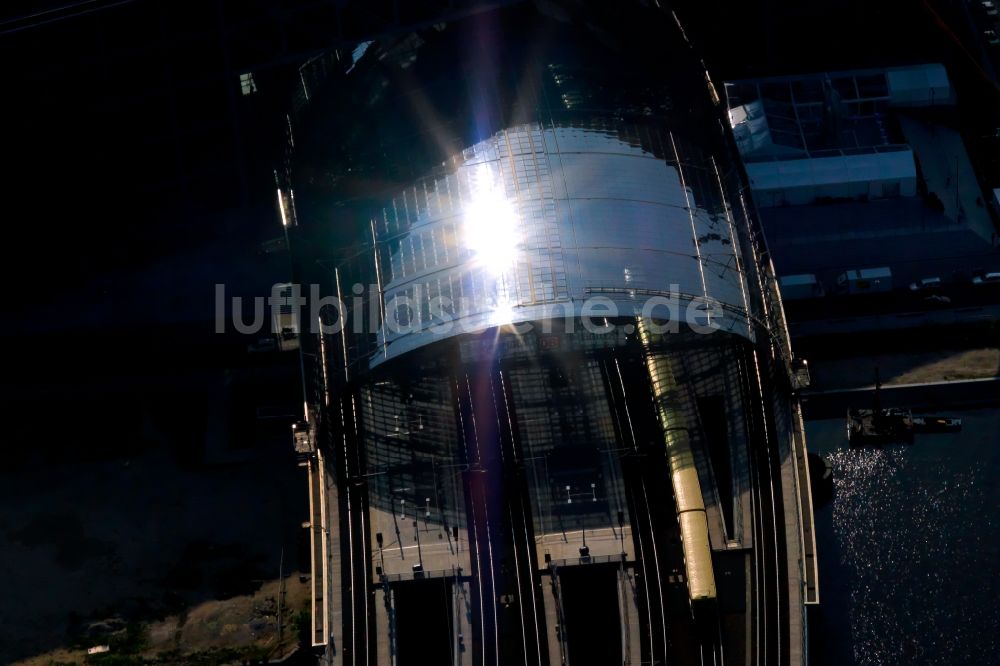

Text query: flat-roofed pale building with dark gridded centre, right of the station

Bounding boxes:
[725,64,955,207]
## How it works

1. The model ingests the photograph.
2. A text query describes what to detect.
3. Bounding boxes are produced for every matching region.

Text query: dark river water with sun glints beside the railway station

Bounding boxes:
[806,409,1000,666]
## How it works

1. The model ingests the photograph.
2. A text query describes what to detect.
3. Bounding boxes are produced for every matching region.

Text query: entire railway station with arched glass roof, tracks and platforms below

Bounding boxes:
[277,2,819,666]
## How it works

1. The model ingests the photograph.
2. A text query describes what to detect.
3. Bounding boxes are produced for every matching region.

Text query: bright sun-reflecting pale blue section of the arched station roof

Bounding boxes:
[375,122,750,357]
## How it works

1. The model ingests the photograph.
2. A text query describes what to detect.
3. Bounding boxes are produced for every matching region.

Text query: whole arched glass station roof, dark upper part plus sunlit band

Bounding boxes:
[285,3,780,368]
